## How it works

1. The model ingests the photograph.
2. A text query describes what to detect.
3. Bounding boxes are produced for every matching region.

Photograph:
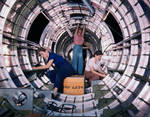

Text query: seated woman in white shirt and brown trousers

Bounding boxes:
[84,51,107,86]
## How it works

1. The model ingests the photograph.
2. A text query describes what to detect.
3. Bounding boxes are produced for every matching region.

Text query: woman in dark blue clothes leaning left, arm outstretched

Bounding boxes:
[32,49,74,97]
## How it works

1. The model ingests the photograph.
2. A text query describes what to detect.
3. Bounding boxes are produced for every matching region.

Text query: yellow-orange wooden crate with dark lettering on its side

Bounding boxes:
[64,76,84,95]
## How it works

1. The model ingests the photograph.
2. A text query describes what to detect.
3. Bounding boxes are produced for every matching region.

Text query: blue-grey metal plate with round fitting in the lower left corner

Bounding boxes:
[0,88,33,110]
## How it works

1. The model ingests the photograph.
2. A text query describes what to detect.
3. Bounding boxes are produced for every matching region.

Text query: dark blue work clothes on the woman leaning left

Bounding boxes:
[47,52,74,92]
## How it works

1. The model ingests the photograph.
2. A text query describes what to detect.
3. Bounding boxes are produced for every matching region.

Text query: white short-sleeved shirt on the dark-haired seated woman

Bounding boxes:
[85,57,102,71]
